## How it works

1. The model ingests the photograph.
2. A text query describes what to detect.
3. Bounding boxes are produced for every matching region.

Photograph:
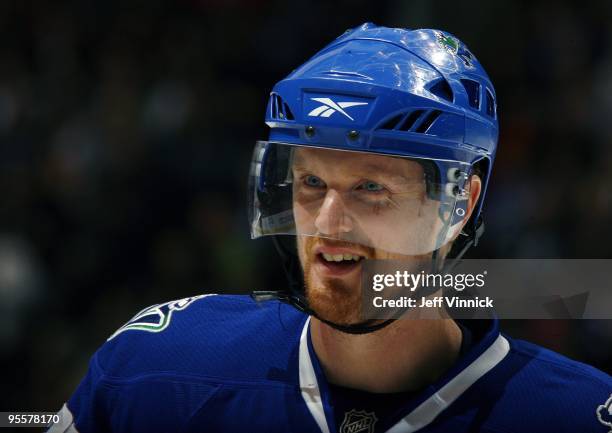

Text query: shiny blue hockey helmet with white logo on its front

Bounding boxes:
[250,23,498,253]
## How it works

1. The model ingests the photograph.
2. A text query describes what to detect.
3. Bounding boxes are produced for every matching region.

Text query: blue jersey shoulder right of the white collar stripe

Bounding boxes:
[464,338,612,432]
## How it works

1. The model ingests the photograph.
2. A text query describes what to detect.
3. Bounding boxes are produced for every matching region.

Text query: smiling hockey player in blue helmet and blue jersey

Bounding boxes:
[51,24,612,433]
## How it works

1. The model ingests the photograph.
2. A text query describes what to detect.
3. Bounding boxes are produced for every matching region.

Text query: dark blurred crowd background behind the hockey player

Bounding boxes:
[0,0,612,411]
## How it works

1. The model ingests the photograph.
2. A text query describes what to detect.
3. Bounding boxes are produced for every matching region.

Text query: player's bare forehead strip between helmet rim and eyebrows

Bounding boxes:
[293,147,423,178]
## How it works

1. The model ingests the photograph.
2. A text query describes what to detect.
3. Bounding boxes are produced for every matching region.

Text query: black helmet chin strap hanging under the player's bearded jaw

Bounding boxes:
[251,218,484,335]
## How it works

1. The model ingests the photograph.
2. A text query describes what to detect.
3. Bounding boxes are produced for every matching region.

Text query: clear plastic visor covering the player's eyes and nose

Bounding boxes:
[249,141,470,257]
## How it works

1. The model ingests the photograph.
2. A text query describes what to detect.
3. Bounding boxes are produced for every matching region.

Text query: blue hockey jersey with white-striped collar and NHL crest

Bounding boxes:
[51,295,612,433]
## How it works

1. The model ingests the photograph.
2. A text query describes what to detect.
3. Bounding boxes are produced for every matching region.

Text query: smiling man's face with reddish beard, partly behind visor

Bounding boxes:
[292,148,441,325]
